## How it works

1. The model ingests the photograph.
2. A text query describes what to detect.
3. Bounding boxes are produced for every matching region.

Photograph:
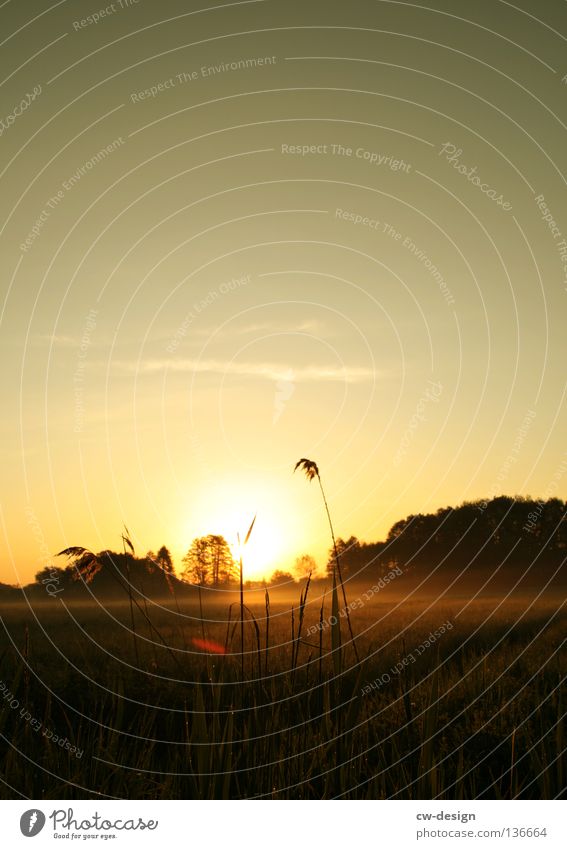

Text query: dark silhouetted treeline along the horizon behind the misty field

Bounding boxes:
[0,496,567,601]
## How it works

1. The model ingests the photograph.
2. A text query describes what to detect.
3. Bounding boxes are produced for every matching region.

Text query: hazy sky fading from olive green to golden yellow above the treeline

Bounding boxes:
[0,0,567,583]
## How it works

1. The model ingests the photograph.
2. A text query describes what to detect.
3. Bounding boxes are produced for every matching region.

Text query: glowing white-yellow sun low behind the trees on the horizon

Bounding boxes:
[186,483,291,581]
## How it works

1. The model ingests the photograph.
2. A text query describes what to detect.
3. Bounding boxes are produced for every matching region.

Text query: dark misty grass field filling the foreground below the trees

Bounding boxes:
[0,582,567,799]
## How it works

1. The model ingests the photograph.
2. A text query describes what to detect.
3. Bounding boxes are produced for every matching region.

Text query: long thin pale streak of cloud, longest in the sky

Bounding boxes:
[114,359,377,383]
